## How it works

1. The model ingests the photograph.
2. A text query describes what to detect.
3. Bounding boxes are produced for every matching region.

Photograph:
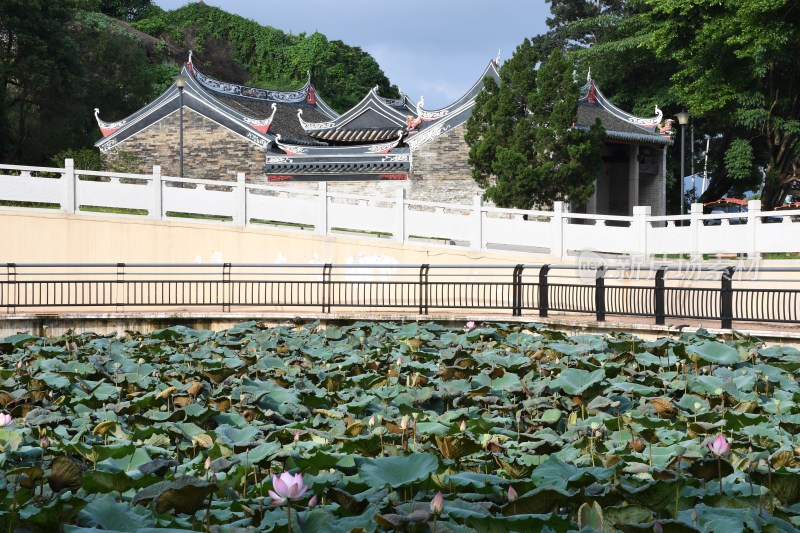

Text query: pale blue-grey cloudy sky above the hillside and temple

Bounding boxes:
[154,0,550,109]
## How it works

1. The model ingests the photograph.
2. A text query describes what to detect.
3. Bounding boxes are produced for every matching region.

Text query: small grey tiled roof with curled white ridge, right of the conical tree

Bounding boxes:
[575,77,674,145]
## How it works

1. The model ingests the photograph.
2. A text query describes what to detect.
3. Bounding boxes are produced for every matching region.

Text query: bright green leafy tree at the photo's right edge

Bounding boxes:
[647,0,800,209]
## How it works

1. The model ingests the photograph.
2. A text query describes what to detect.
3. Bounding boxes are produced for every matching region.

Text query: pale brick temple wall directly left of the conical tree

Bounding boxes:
[408,124,482,205]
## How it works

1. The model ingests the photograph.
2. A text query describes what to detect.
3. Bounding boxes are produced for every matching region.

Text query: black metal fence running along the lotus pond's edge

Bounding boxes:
[0,263,800,328]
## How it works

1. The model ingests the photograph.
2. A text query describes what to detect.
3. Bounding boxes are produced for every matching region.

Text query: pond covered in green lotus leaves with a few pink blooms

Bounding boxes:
[0,322,800,533]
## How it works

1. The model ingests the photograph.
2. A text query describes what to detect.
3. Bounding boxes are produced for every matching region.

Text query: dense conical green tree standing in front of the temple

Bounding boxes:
[465,39,605,209]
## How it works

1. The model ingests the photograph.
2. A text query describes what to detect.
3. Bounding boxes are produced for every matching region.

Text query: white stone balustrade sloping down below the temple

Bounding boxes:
[0,160,800,258]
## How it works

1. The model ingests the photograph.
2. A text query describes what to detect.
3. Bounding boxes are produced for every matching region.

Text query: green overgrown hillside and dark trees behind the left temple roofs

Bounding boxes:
[0,0,397,166]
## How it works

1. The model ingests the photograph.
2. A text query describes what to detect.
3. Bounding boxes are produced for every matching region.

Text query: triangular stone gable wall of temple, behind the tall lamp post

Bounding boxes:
[105,107,265,181]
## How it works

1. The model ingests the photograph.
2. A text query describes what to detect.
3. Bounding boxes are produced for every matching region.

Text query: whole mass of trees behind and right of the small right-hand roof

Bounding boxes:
[539,0,800,208]
